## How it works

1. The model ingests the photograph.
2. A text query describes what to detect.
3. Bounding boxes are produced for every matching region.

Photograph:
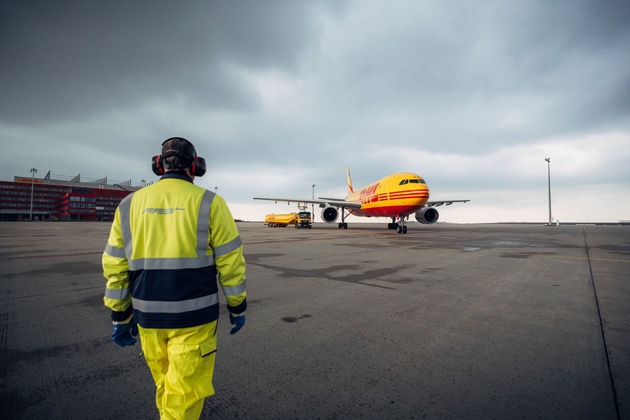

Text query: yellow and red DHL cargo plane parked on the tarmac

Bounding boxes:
[254,168,470,233]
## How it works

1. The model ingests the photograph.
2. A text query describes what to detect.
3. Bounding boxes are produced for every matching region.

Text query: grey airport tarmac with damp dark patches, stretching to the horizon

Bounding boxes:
[0,218,630,419]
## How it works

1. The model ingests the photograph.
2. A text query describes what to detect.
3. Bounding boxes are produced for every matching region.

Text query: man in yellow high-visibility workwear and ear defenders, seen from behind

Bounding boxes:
[103,137,247,419]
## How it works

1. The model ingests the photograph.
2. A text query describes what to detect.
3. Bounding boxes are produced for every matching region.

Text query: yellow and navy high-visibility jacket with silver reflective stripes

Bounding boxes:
[103,172,247,328]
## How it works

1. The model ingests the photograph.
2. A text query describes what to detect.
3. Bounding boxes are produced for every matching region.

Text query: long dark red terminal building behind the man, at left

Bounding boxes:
[0,171,148,222]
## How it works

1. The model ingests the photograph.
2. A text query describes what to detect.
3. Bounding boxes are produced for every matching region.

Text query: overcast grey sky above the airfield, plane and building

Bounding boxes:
[0,0,630,222]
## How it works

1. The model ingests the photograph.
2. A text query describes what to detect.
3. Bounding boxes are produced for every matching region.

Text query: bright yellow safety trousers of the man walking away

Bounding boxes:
[138,321,217,420]
